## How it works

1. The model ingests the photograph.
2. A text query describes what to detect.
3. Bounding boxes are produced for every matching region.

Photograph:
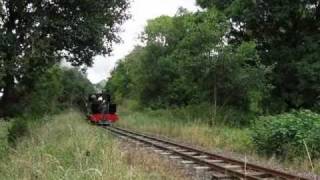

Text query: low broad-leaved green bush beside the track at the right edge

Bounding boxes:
[251,110,320,158]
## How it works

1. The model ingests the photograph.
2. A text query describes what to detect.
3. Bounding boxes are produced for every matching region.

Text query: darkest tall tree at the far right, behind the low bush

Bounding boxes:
[198,0,320,109]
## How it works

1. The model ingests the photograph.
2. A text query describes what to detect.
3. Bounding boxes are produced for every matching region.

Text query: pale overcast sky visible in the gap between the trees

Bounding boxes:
[88,0,198,83]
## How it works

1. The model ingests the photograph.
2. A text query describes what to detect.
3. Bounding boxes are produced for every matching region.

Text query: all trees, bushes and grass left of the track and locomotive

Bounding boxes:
[0,0,135,179]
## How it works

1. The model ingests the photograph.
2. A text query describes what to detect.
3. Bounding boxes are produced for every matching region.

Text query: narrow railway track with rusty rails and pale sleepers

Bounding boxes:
[105,127,308,180]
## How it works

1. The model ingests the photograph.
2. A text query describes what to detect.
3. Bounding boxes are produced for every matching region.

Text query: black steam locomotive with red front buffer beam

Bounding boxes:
[88,93,119,126]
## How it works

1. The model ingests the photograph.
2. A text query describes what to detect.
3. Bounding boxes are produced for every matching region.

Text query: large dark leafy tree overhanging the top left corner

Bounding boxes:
[0,0,128,115]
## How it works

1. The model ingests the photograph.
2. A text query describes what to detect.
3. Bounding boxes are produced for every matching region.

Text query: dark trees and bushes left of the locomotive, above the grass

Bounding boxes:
[0,0,129,153]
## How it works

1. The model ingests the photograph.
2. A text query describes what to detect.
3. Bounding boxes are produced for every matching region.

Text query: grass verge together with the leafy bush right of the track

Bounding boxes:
[119,103,320,174]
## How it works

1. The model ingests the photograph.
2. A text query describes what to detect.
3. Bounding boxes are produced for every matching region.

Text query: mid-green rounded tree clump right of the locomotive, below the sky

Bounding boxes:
[106,10,271,121]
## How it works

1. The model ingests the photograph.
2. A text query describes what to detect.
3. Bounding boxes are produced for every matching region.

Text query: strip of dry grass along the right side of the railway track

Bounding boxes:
[119,109,320,177]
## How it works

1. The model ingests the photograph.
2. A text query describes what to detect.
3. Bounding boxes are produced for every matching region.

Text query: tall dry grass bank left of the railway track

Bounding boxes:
[0,111,189,180]
